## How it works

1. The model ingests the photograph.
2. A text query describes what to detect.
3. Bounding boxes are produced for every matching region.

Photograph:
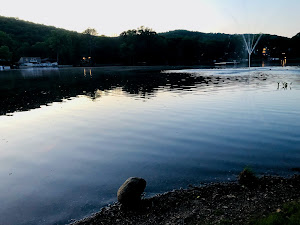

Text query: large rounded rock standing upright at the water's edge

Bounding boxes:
[117,177,146,206]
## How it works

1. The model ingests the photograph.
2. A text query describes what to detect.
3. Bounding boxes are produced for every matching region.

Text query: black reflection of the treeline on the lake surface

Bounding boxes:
[0,68,274,115]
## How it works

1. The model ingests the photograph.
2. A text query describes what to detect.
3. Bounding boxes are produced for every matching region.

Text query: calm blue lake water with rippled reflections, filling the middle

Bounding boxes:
[0,67,300,225]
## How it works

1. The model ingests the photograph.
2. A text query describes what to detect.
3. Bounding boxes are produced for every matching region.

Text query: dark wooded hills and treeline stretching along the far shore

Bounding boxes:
[0,16,300,65]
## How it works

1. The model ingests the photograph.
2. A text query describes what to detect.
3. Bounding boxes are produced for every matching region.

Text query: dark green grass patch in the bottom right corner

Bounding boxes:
[250,201,300,225]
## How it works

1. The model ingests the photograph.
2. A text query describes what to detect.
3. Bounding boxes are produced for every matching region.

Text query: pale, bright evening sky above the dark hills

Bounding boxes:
[0,0,300,37]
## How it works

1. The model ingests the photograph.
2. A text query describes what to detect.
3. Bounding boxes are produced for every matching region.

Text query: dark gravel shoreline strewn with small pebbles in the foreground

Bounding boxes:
[72,175,300,225]
